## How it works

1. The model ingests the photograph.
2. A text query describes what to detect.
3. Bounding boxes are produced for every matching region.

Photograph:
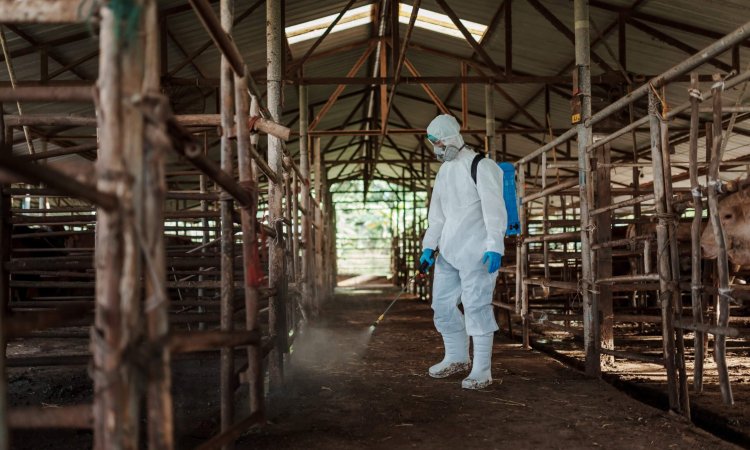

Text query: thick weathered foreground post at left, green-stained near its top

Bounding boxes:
[91,0,150,450]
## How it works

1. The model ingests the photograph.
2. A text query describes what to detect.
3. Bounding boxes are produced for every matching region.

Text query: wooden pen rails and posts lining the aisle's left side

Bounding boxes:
[0,0,335,449]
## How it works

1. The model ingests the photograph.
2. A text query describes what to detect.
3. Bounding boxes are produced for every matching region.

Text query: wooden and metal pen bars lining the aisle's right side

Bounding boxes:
[506,8,750,417]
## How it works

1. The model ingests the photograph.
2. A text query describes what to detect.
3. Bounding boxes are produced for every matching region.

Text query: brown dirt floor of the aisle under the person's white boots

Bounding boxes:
[4,284,738,450]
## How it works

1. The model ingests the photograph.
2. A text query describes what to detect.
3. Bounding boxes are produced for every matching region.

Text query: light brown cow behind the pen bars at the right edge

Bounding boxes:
[701,187,750,266]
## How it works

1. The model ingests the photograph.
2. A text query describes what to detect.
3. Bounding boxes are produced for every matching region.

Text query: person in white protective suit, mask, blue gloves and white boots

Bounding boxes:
[420,115,508,389]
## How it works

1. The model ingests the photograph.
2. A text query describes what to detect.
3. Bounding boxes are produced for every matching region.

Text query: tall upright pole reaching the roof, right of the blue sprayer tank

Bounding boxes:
[576,0,601,376]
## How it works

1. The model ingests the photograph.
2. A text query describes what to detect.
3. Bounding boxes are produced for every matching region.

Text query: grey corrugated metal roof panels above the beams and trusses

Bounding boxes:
[0,0,750,188]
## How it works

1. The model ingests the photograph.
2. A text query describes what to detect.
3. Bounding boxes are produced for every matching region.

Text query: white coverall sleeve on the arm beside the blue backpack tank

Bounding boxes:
[477,159,508,255]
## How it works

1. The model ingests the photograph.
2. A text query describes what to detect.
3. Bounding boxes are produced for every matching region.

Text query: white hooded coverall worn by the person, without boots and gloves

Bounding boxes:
[422,116,508,336]
